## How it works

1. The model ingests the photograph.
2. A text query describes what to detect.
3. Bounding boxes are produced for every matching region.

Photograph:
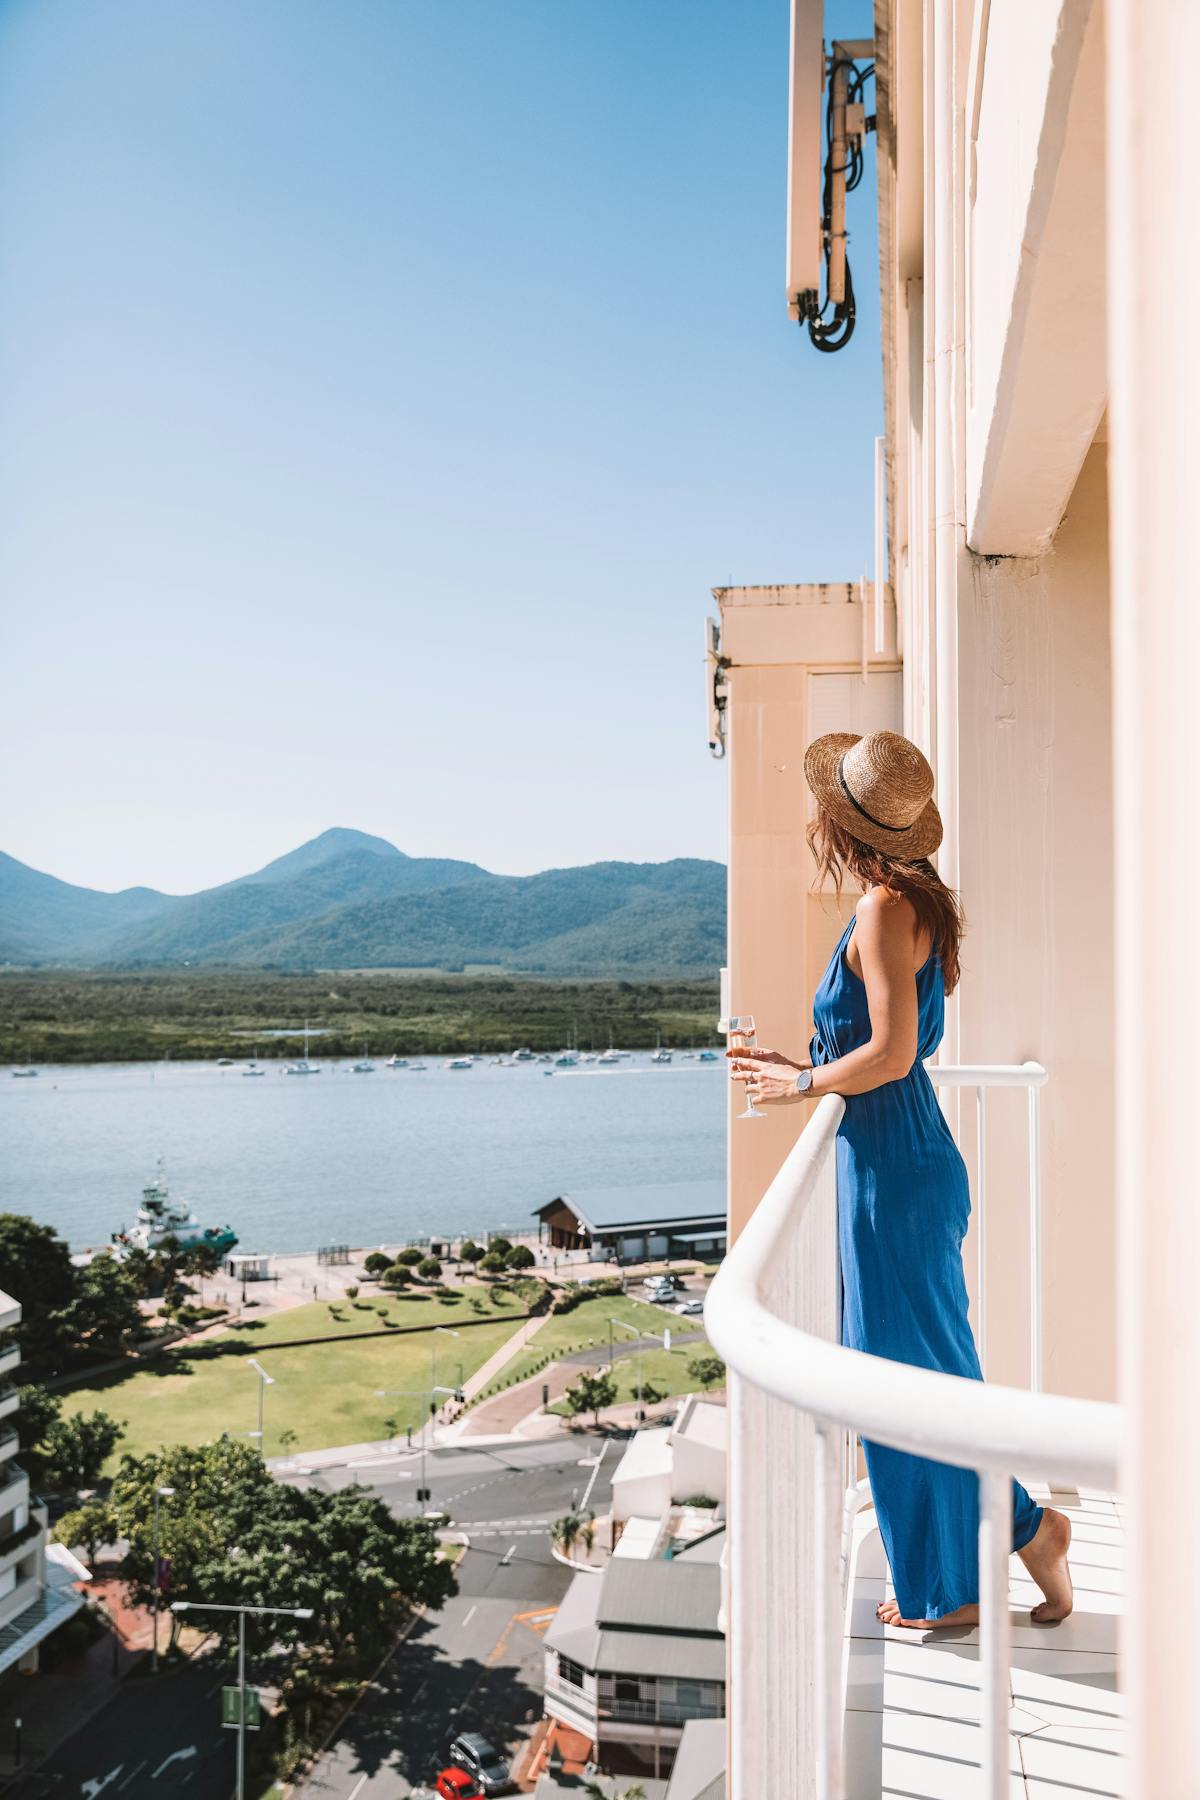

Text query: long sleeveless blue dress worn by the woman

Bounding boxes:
[811,920,1042,1618]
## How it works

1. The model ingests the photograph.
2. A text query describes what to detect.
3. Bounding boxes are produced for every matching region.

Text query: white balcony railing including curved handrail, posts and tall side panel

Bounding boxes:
[705,1064,1119,1800]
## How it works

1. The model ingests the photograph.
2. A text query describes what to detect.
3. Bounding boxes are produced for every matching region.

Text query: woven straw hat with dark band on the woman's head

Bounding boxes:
[804,731,941,862]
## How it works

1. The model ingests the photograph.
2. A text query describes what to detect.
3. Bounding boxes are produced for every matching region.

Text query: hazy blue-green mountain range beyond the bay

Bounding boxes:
[0,826,725,977]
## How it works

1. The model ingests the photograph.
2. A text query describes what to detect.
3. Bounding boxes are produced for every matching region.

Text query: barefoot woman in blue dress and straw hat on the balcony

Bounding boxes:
[732,731,1072,1627]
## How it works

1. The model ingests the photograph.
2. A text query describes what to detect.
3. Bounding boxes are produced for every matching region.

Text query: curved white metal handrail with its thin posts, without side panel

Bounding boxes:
[705,1064,1119,1800]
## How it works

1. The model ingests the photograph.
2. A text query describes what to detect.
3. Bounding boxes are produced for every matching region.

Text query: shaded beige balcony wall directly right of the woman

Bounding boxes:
[957,443,1115,1400]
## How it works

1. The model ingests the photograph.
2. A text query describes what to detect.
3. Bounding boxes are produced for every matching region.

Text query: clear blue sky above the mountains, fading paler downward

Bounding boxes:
[0,0,880,891]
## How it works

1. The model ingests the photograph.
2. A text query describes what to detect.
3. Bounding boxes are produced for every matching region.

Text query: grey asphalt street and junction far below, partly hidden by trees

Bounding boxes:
[14,1433,624,1800]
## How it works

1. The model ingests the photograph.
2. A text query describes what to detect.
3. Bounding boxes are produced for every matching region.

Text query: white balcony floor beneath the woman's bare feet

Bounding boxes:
[846,1481,1126,1800]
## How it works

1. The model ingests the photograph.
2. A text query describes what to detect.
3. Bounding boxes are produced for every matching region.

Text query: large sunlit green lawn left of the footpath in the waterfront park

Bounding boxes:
[63,1321,516,1467]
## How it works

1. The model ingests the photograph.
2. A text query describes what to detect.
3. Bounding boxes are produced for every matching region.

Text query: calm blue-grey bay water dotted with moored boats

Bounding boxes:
[0,1053,725,1251]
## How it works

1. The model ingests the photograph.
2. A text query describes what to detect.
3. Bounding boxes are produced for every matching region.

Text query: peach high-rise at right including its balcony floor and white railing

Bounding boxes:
[707,0,1200,1800]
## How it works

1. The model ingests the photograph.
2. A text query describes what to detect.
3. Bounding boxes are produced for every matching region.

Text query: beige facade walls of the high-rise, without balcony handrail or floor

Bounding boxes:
[716,0,1200,1800]
